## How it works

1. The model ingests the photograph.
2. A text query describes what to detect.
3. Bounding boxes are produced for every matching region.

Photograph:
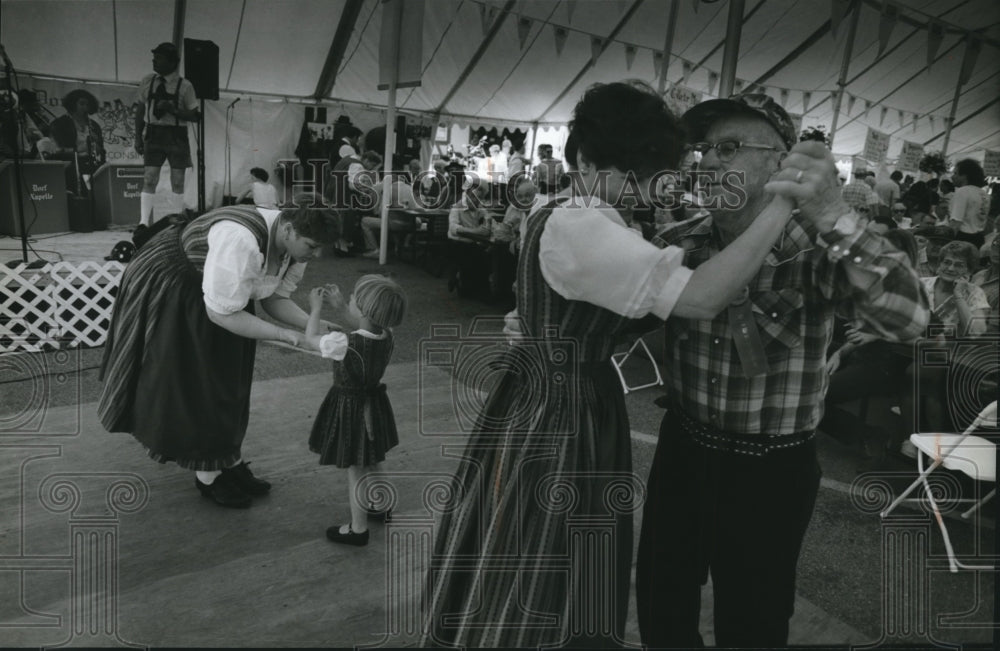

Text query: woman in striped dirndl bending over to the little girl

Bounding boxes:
[98,196,339,508]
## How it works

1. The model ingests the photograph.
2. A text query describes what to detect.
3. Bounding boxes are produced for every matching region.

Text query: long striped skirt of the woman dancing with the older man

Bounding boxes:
[420,354,643,647]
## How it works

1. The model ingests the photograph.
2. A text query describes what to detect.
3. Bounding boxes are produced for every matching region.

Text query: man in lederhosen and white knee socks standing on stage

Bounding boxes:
[135,43,201,226]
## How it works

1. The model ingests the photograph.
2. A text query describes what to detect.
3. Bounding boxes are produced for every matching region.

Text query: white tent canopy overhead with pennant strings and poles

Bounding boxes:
[0,0,1000,158]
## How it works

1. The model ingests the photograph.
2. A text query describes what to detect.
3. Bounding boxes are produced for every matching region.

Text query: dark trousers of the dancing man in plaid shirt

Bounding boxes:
[636,420,820,648]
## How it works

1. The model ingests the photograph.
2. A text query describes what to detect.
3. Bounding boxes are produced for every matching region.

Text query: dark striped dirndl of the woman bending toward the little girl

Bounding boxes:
[98,226,256,470]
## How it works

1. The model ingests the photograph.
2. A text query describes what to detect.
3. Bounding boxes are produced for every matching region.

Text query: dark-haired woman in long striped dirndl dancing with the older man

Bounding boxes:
[420,82,792,647]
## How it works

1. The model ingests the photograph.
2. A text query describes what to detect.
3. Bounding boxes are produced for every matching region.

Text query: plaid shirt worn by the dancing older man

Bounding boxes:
[653,216,929,435]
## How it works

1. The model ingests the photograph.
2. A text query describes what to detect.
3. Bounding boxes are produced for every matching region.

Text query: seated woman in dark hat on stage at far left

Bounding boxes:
[51,88,107,194]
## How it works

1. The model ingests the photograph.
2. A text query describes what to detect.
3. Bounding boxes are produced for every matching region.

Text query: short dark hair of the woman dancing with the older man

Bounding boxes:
[566,80,684,178]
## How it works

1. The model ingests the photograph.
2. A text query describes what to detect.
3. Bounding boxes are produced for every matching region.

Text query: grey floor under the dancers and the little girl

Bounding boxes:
[0,234,995,647]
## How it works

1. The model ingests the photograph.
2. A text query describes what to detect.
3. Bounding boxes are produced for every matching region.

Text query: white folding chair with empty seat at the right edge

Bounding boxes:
[881,401,997,572]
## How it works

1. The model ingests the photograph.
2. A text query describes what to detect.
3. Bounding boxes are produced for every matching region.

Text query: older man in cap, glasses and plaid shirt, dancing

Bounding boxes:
[636,94,929,648]
